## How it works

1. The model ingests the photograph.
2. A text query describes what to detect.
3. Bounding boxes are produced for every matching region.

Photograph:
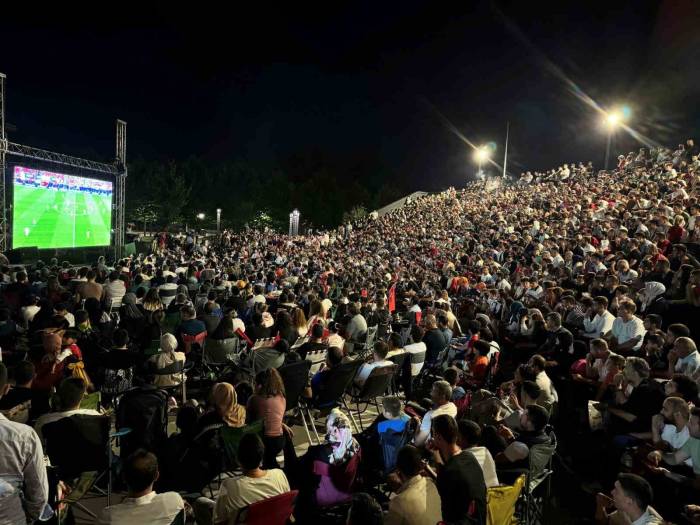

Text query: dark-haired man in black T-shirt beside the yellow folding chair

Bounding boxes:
[431,415,486,524]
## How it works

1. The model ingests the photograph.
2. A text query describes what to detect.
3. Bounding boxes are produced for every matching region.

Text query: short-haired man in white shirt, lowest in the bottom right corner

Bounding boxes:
[595,474,665,525]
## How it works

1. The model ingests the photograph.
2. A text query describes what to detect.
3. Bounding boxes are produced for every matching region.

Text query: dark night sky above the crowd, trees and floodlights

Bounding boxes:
[0,0,700,189]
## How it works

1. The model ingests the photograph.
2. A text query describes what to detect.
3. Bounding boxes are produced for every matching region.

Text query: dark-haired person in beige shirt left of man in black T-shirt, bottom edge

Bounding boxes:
[384,445,442,525]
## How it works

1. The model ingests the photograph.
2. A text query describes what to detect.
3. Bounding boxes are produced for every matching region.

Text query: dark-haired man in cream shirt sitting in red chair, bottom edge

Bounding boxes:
[195,434,289,525]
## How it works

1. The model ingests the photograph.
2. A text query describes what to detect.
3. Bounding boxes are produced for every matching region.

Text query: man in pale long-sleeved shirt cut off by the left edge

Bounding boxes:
[0,363,50,523]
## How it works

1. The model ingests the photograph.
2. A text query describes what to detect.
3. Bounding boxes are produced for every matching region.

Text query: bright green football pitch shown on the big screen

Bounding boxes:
[12,184,112,248]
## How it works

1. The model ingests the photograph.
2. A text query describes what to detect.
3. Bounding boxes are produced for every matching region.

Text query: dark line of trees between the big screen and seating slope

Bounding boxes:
[126,152,409,231]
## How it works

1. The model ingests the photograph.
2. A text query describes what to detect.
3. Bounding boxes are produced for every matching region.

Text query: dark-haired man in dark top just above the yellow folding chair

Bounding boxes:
[484,405,551,468]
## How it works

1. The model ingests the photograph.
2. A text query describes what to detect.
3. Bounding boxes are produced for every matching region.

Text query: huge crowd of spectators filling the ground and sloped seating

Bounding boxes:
[0,140,700,525]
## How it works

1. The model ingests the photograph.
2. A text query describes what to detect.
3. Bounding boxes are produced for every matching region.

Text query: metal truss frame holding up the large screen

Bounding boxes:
[0,73,127,259]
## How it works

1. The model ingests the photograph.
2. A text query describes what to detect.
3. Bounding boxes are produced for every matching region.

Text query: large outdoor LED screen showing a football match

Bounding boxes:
[12,166,112,248]
